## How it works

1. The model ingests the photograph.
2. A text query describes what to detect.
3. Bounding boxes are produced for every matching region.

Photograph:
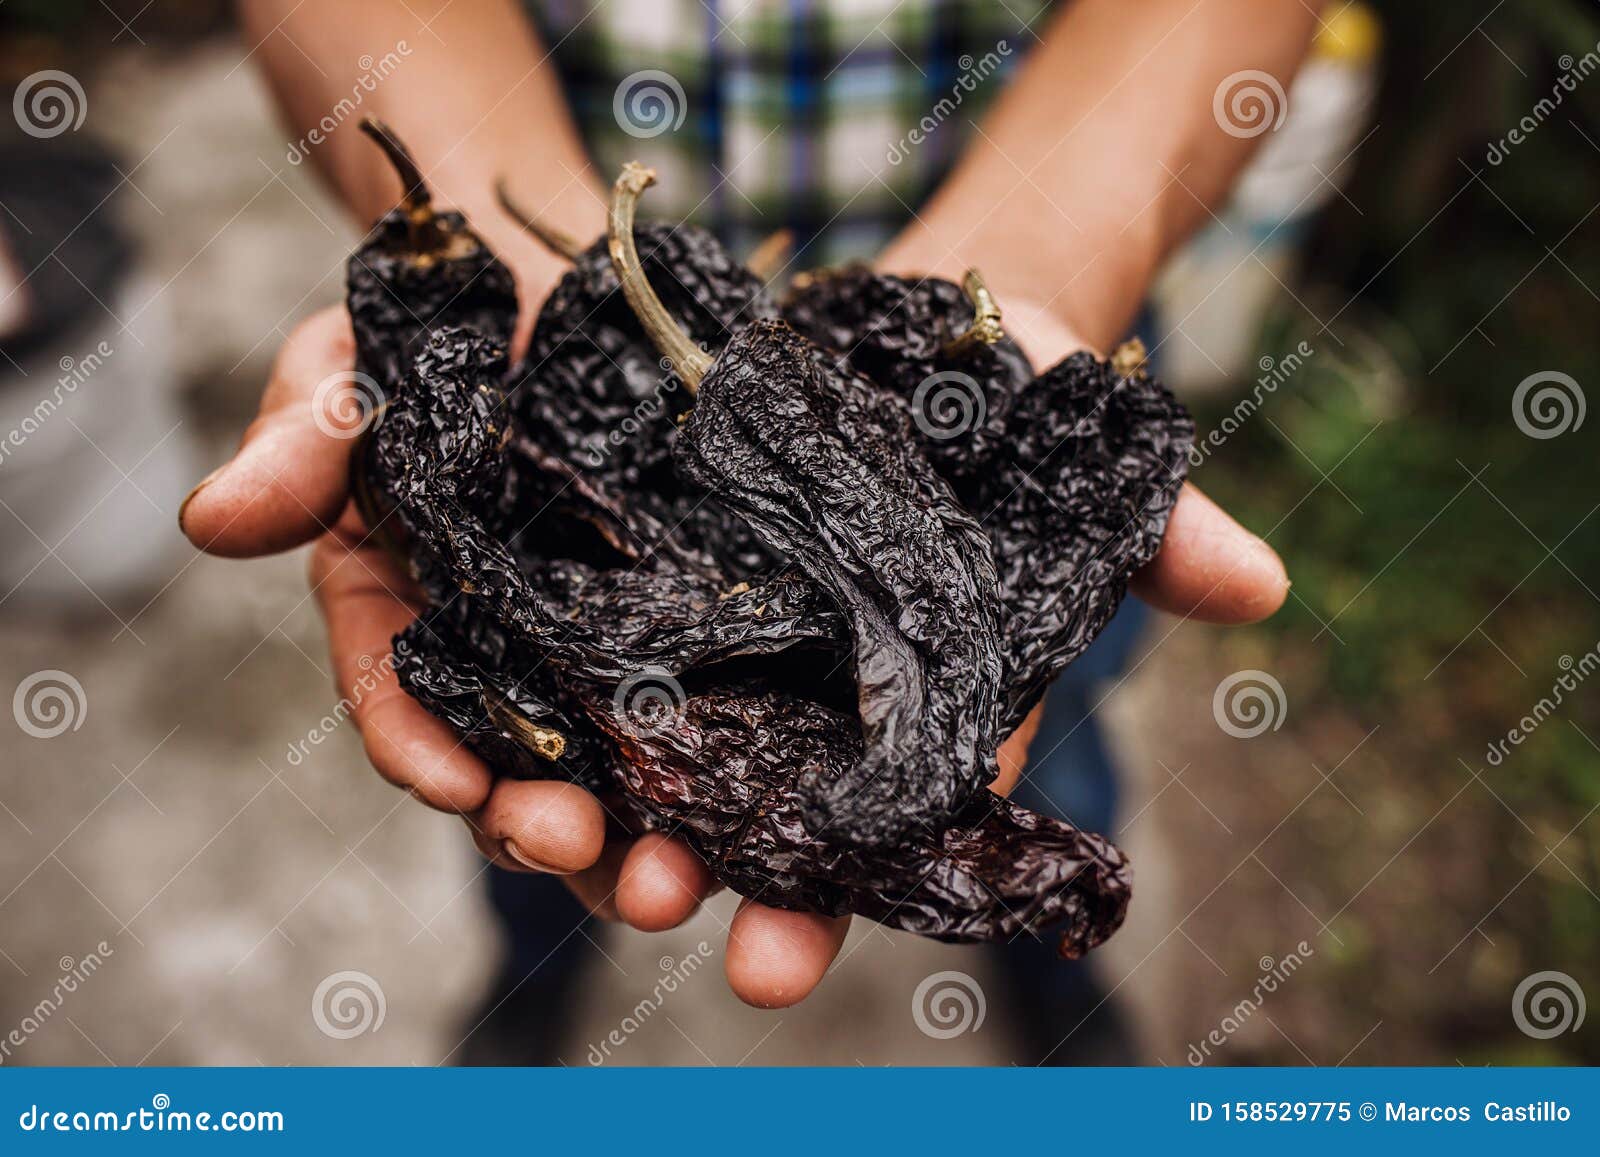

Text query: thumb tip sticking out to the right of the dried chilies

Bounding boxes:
[1131,483,1290,623]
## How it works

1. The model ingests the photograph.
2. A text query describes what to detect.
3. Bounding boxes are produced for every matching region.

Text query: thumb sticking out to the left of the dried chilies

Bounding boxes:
[178,307,358,558]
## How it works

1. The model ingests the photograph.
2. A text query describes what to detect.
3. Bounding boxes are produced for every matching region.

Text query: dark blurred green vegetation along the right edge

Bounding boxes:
[1197,0,1600,1063]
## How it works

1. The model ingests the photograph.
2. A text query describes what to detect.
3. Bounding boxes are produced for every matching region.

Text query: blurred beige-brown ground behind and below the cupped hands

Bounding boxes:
[0,38,1536,1064]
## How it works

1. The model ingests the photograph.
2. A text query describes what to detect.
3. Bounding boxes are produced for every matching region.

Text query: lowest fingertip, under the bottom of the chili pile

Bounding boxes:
[723,899,850,1008]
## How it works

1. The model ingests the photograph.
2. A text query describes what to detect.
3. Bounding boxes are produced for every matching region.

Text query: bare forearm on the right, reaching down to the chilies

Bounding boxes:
[882,0,1317,347]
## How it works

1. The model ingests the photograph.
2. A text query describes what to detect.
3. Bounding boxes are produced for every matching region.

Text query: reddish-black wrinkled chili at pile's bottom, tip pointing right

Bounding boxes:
[595,685,1131,957]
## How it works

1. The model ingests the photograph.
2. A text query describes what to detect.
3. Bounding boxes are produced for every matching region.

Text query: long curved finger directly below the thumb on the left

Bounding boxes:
[310,512,493,811]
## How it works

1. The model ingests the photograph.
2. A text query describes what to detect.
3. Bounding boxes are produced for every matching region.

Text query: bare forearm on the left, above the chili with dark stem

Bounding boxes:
[240,0,605,288]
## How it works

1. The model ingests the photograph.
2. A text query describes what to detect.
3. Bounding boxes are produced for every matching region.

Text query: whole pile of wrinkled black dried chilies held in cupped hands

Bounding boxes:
[350,125,1192,955]
